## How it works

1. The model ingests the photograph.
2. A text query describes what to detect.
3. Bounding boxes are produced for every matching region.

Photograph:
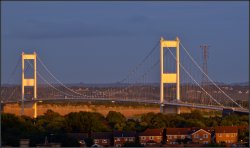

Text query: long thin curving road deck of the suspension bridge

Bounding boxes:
[1,98,249,114]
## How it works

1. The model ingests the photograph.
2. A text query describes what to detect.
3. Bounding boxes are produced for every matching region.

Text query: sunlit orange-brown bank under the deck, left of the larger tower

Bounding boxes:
[3,102,160,118]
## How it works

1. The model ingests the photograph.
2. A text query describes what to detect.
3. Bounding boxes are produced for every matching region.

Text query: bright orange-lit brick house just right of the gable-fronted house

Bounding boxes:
[215,126,238,144]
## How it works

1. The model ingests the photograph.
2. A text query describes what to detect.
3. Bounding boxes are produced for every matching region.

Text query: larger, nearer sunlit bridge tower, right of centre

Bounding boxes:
[160,37,180,114]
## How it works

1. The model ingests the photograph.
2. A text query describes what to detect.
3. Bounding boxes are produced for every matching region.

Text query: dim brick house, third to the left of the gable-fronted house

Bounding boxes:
[114,131,136,147]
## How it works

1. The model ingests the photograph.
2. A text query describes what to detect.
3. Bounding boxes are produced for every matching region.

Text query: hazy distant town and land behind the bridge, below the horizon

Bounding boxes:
[2,83,249,108]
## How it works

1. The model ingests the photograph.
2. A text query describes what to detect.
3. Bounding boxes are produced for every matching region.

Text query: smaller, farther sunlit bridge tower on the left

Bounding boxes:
[21,52,37,118]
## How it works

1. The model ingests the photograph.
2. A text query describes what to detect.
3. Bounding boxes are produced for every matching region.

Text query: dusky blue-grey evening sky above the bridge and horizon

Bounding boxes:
[1,1,249,83]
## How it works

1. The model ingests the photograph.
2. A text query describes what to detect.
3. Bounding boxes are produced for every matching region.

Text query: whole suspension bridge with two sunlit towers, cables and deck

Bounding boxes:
[1,37,249,118]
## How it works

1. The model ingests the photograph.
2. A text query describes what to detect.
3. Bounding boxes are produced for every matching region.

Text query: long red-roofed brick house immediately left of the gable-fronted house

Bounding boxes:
[167,128,192,144]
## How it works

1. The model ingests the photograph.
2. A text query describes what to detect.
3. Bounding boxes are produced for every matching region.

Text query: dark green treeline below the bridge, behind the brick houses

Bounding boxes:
[1,110,249,146]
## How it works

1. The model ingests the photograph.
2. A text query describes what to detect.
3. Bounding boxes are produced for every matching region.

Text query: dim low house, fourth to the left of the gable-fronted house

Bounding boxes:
[91,132,113,147]
